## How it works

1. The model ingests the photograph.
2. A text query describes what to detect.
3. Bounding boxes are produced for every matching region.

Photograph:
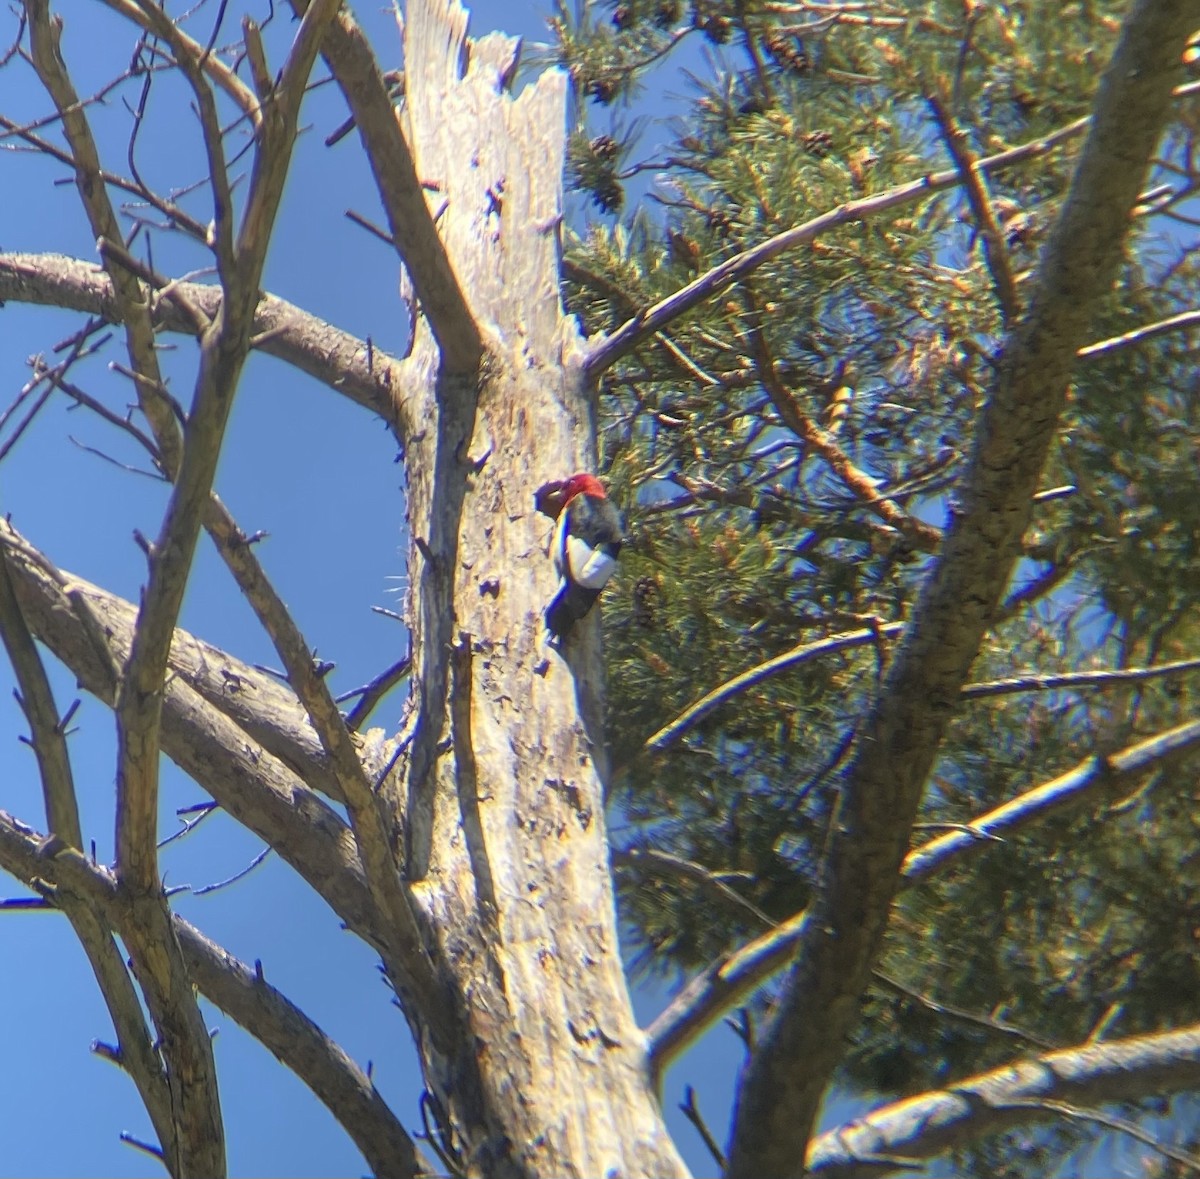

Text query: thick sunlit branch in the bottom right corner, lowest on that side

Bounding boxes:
[805,1024,1200,1179]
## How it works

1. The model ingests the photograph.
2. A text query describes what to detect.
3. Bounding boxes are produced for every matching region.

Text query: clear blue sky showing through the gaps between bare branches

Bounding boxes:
[0,2,758,1177]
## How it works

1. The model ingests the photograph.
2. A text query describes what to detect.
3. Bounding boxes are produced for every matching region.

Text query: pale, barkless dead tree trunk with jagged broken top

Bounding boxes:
[360,0,685,1177]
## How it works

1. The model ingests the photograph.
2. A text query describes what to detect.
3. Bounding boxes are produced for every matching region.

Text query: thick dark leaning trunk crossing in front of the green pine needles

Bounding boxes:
[728,0,1198,1179]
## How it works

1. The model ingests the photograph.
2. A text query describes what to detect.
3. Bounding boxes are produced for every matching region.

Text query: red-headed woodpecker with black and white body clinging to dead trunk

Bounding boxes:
[534,473,625,639]
